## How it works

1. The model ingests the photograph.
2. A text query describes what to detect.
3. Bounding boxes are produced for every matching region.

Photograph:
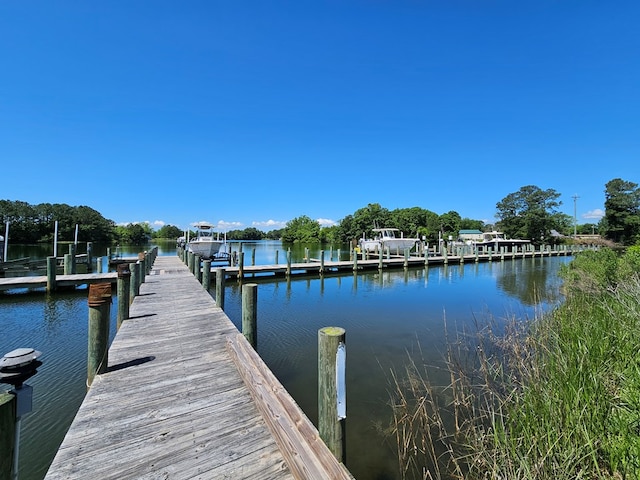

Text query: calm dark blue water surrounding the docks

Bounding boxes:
[0,242,569,480]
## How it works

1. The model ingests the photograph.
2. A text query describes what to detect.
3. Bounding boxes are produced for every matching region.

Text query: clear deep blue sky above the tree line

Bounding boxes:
[0,0,640,230]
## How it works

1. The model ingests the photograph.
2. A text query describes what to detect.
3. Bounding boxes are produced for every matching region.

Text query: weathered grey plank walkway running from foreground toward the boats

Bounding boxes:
[46,256,352,480]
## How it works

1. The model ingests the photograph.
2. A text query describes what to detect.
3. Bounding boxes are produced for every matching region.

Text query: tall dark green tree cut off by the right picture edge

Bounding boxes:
[600,178,640,245]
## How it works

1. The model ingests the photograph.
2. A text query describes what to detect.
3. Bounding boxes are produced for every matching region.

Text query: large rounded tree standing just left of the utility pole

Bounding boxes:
[496,185,563,244]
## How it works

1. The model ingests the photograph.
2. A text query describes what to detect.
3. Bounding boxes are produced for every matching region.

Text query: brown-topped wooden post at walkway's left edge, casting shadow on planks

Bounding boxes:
[87,283,111,387]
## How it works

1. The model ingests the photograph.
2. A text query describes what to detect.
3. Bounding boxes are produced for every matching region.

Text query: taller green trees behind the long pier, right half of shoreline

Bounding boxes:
[282,178,640,245]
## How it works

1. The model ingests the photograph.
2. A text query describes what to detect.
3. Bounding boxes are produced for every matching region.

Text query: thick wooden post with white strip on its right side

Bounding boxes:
[318,327,347,463]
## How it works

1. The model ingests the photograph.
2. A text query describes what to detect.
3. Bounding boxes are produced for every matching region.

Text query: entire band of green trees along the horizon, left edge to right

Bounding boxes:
[0,178,640,245]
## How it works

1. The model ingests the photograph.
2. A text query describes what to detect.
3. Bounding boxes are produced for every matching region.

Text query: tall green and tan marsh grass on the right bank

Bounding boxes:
[390,247,640,480]
